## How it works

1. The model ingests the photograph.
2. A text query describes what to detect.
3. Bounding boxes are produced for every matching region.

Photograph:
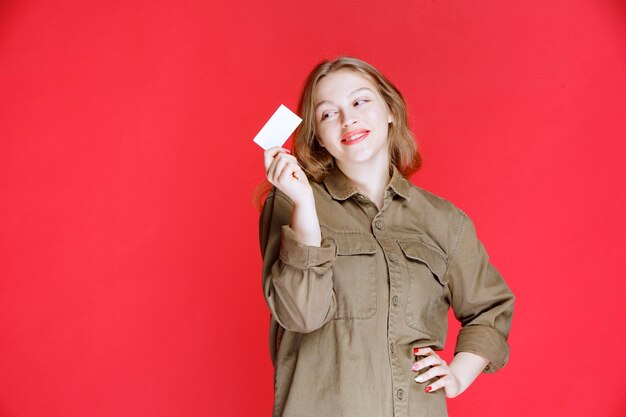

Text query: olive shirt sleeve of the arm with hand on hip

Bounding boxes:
[448,213,515,373]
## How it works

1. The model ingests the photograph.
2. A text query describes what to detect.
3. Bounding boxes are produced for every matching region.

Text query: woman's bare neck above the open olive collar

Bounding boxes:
[337,157,390,210]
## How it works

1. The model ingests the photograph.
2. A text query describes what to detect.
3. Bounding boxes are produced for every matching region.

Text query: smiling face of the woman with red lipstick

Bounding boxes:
[314,70,393,168]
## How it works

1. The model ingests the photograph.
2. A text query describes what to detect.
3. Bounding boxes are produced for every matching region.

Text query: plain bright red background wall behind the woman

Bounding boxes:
[0,0,626,417]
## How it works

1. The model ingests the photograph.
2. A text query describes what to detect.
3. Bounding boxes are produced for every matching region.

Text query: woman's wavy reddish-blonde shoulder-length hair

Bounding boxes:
[254,56,422,210]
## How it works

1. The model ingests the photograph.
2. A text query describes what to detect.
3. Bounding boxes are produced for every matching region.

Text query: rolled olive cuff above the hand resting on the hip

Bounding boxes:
[454,325,509,374]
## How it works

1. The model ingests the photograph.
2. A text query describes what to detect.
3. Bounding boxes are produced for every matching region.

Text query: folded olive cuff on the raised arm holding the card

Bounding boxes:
[280,225,337,273]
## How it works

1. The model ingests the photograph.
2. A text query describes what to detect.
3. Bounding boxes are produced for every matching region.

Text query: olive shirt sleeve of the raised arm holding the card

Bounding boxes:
[259,189,337,333]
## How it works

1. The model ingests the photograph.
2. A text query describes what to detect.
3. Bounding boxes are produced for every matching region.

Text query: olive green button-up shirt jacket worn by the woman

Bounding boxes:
[260,167,514,417]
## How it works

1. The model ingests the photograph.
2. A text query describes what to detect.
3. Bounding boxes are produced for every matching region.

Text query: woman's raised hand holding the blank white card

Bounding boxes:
[264,146,313,205]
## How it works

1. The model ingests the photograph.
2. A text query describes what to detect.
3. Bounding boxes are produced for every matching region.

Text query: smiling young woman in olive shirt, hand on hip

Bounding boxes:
[260,57,514,417]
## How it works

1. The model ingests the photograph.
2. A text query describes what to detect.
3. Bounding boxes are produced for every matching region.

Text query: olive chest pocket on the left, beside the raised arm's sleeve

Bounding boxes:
[332,232,378,320]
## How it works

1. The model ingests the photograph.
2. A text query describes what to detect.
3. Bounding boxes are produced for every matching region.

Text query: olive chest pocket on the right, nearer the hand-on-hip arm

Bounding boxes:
[398,241,450,338]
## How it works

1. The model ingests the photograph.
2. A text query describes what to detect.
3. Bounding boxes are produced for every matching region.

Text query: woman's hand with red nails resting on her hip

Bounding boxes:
[412,347,462,398]
